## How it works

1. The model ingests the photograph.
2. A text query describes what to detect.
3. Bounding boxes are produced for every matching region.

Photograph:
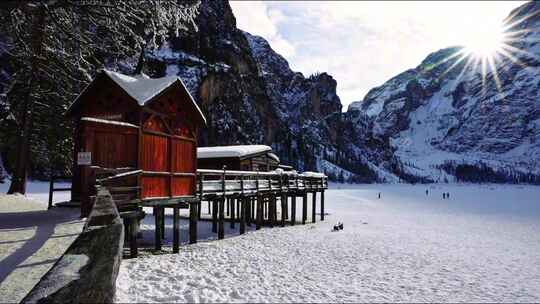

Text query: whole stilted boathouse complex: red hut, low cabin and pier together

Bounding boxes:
[61,70,327,256]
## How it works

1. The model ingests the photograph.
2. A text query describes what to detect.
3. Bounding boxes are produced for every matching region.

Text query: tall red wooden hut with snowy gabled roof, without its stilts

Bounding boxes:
[67,70,206,216]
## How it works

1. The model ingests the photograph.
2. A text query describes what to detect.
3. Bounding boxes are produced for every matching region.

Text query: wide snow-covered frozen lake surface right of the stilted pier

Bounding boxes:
[117,185,540,302]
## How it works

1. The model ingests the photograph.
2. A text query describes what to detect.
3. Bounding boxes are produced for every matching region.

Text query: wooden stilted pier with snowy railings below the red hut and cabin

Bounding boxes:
[96,169,328,257]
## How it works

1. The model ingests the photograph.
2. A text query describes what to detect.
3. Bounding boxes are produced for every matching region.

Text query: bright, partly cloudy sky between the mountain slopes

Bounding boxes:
[230,1,524,110]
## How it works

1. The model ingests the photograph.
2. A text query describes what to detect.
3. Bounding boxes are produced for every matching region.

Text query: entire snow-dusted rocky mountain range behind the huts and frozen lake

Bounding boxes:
[0,0,540,183]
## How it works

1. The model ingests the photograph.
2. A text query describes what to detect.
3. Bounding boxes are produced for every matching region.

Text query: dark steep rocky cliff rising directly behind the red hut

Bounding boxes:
[142,1,368,176]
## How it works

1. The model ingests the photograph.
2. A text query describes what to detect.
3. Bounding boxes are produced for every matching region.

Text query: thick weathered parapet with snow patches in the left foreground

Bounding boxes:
[21,190,124,303]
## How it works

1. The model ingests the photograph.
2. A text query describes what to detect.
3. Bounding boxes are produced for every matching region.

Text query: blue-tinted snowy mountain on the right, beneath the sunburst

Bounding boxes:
[348,2,540,182]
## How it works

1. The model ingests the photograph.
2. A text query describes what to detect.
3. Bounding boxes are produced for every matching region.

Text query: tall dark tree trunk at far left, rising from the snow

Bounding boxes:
[8,5,45,194]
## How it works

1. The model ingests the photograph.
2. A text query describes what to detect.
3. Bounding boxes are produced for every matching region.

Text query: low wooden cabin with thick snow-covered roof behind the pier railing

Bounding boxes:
[197,145,279,171]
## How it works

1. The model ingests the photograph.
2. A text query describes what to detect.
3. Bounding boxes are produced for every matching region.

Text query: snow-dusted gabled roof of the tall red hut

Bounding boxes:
[67,69,206,123]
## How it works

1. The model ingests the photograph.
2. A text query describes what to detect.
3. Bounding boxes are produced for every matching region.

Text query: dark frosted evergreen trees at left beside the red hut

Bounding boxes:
[0,0,199,193]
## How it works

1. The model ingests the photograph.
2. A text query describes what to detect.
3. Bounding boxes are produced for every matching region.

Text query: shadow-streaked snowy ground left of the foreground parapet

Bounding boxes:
[0,182,84,303]
